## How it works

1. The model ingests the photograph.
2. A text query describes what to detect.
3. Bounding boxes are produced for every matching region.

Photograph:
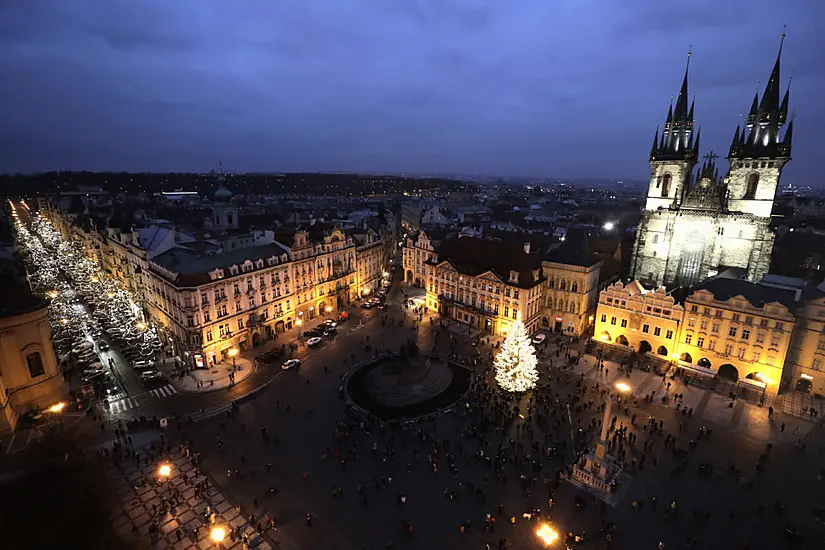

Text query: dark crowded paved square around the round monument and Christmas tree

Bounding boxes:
[132,298,825,550]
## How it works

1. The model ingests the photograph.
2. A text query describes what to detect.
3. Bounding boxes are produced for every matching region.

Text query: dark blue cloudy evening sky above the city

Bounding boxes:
[0,0,825,184]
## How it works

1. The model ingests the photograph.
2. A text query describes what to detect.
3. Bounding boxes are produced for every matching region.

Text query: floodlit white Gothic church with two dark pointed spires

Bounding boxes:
[631,34,793,288]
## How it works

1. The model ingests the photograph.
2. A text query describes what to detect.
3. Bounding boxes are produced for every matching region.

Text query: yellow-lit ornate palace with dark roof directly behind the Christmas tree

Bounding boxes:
[426,237,544,335]
